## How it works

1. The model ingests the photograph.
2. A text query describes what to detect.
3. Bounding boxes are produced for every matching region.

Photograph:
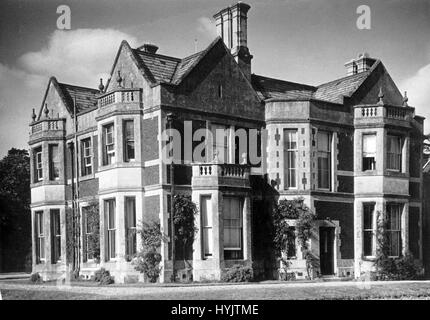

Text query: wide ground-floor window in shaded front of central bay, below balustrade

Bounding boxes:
[223,197,243,260]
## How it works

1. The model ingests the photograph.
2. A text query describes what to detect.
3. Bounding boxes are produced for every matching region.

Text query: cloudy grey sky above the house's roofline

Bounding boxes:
[0,0,430,157]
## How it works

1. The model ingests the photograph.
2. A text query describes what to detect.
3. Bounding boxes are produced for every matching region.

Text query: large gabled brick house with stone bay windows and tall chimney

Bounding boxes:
[29,3,424,282]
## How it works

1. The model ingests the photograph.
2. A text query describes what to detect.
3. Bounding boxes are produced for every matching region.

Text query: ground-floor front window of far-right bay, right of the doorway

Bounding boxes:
[387,204,402,257]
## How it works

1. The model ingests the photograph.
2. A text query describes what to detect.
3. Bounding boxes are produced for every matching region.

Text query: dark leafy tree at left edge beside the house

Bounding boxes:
[0,148,31,271]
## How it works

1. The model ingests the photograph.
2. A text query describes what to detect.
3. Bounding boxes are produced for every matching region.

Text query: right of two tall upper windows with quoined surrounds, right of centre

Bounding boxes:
[317,131,331,189]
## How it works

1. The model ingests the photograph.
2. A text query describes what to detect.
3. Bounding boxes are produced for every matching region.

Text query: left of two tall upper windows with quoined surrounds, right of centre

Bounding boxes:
[284,129,297,189]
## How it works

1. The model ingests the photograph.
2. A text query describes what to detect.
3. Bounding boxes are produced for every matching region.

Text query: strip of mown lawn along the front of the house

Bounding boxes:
[0,280,430,300]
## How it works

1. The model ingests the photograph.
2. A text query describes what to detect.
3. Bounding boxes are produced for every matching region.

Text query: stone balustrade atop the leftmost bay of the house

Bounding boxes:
[29,118,66,144]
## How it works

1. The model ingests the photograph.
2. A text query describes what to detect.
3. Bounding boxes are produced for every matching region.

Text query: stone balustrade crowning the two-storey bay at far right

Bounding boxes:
[354,104,415,127]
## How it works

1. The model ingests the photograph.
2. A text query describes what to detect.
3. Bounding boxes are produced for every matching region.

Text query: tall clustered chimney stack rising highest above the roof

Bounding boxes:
[214,2,252,79]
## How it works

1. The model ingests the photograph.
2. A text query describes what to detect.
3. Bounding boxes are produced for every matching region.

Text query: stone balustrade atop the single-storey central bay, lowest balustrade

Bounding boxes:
[192,163,250,188]
